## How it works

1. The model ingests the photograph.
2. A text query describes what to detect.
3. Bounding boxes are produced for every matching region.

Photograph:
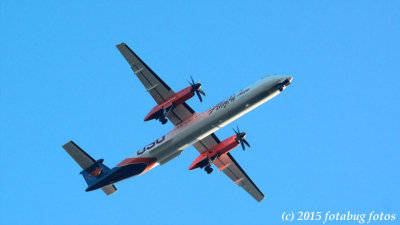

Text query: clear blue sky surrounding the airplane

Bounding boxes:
[0,1,400,225]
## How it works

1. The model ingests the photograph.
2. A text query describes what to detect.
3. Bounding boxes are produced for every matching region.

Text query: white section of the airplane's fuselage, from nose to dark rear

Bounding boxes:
[130,76,291,169]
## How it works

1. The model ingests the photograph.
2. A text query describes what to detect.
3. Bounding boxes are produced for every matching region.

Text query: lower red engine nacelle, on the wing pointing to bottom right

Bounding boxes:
[189,135,239,170]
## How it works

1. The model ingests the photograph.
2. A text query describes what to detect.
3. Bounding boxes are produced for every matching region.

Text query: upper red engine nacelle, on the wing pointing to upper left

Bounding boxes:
[144,86,194,124]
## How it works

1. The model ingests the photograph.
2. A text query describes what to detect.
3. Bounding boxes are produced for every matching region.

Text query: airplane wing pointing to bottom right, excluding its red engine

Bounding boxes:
[193,133,265,202]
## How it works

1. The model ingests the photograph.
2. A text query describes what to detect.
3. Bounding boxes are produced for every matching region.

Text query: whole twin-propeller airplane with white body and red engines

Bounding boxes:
[63,43,293,202]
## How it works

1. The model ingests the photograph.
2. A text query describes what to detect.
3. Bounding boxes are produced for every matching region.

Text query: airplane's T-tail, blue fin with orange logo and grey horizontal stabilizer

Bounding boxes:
[63,141,117,195]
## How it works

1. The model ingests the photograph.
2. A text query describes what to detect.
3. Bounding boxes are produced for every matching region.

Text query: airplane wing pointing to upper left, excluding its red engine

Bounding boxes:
[117,43,194,126]
